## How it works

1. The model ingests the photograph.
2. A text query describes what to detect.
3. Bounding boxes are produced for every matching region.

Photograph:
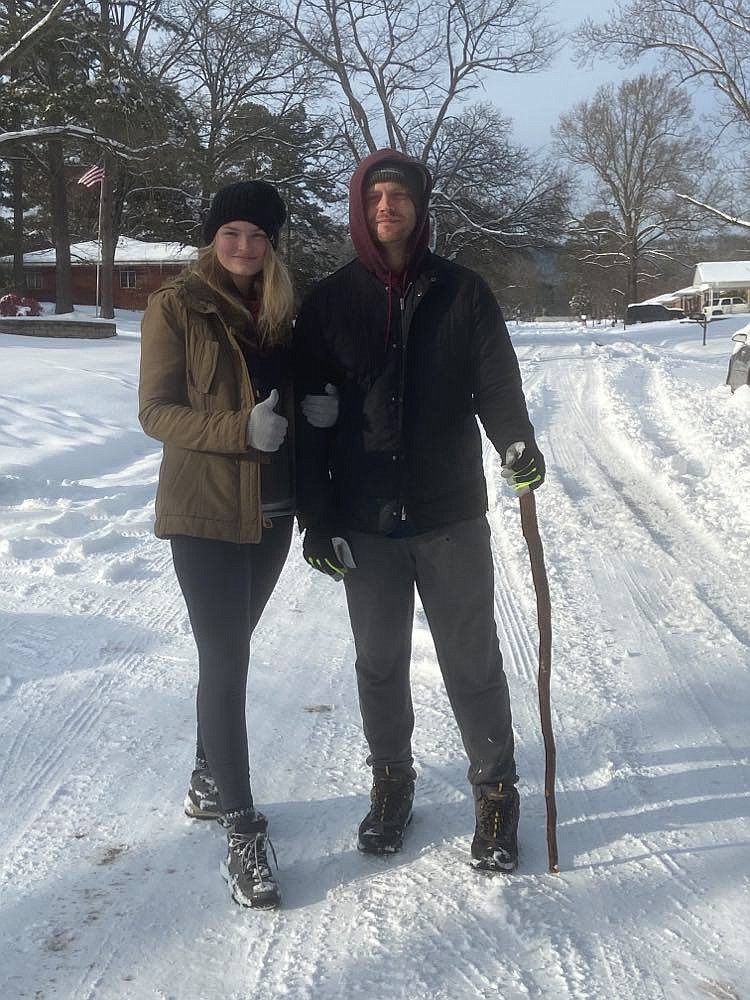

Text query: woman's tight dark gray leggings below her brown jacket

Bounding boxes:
[171,517,293,812]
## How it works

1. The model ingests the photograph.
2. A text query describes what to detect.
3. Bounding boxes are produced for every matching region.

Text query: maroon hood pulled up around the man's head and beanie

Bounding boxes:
[349,149,432,287]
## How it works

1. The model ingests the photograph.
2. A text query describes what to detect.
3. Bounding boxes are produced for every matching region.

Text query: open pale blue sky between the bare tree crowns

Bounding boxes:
[485,0,716,149]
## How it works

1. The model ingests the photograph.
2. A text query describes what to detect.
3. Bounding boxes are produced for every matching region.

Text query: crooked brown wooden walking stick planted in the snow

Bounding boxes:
[519,491,560,874]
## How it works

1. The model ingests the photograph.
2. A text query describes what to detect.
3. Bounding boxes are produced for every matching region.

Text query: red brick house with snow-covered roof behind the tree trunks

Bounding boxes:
[9,236,198,309]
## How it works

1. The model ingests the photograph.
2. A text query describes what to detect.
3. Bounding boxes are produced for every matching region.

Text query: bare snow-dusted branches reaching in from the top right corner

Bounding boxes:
[576,0,750,228]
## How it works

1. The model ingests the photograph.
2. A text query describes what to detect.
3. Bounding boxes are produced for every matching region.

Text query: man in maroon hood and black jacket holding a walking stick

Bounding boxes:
[295,150,544,872]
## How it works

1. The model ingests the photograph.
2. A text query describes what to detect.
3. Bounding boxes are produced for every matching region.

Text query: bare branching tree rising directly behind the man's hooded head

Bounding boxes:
[256,0,556,244]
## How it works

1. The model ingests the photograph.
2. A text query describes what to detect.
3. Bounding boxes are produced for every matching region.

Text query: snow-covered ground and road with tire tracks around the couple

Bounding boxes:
[0,314,750,1000]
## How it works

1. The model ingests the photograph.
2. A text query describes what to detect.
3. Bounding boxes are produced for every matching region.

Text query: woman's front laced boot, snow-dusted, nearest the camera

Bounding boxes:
[221,812,281,909]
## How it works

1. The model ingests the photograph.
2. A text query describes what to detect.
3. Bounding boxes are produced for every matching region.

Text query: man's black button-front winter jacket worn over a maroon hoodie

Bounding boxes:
[294,253,534,534]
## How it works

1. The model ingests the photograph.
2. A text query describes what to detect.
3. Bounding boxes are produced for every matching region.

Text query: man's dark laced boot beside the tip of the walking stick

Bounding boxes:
[471,785,520,874]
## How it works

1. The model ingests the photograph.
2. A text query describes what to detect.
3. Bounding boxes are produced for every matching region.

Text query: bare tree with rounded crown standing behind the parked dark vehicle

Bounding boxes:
[555,73,716,302]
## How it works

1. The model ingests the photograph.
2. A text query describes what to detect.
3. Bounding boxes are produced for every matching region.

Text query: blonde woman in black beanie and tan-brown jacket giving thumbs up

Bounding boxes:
[139,181,337,906]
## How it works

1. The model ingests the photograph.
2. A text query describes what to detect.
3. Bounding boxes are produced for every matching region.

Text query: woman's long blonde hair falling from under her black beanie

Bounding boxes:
[189,240,294,344]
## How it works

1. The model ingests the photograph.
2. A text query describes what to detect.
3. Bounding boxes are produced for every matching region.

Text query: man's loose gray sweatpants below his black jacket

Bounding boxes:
[345,517,517,786]
